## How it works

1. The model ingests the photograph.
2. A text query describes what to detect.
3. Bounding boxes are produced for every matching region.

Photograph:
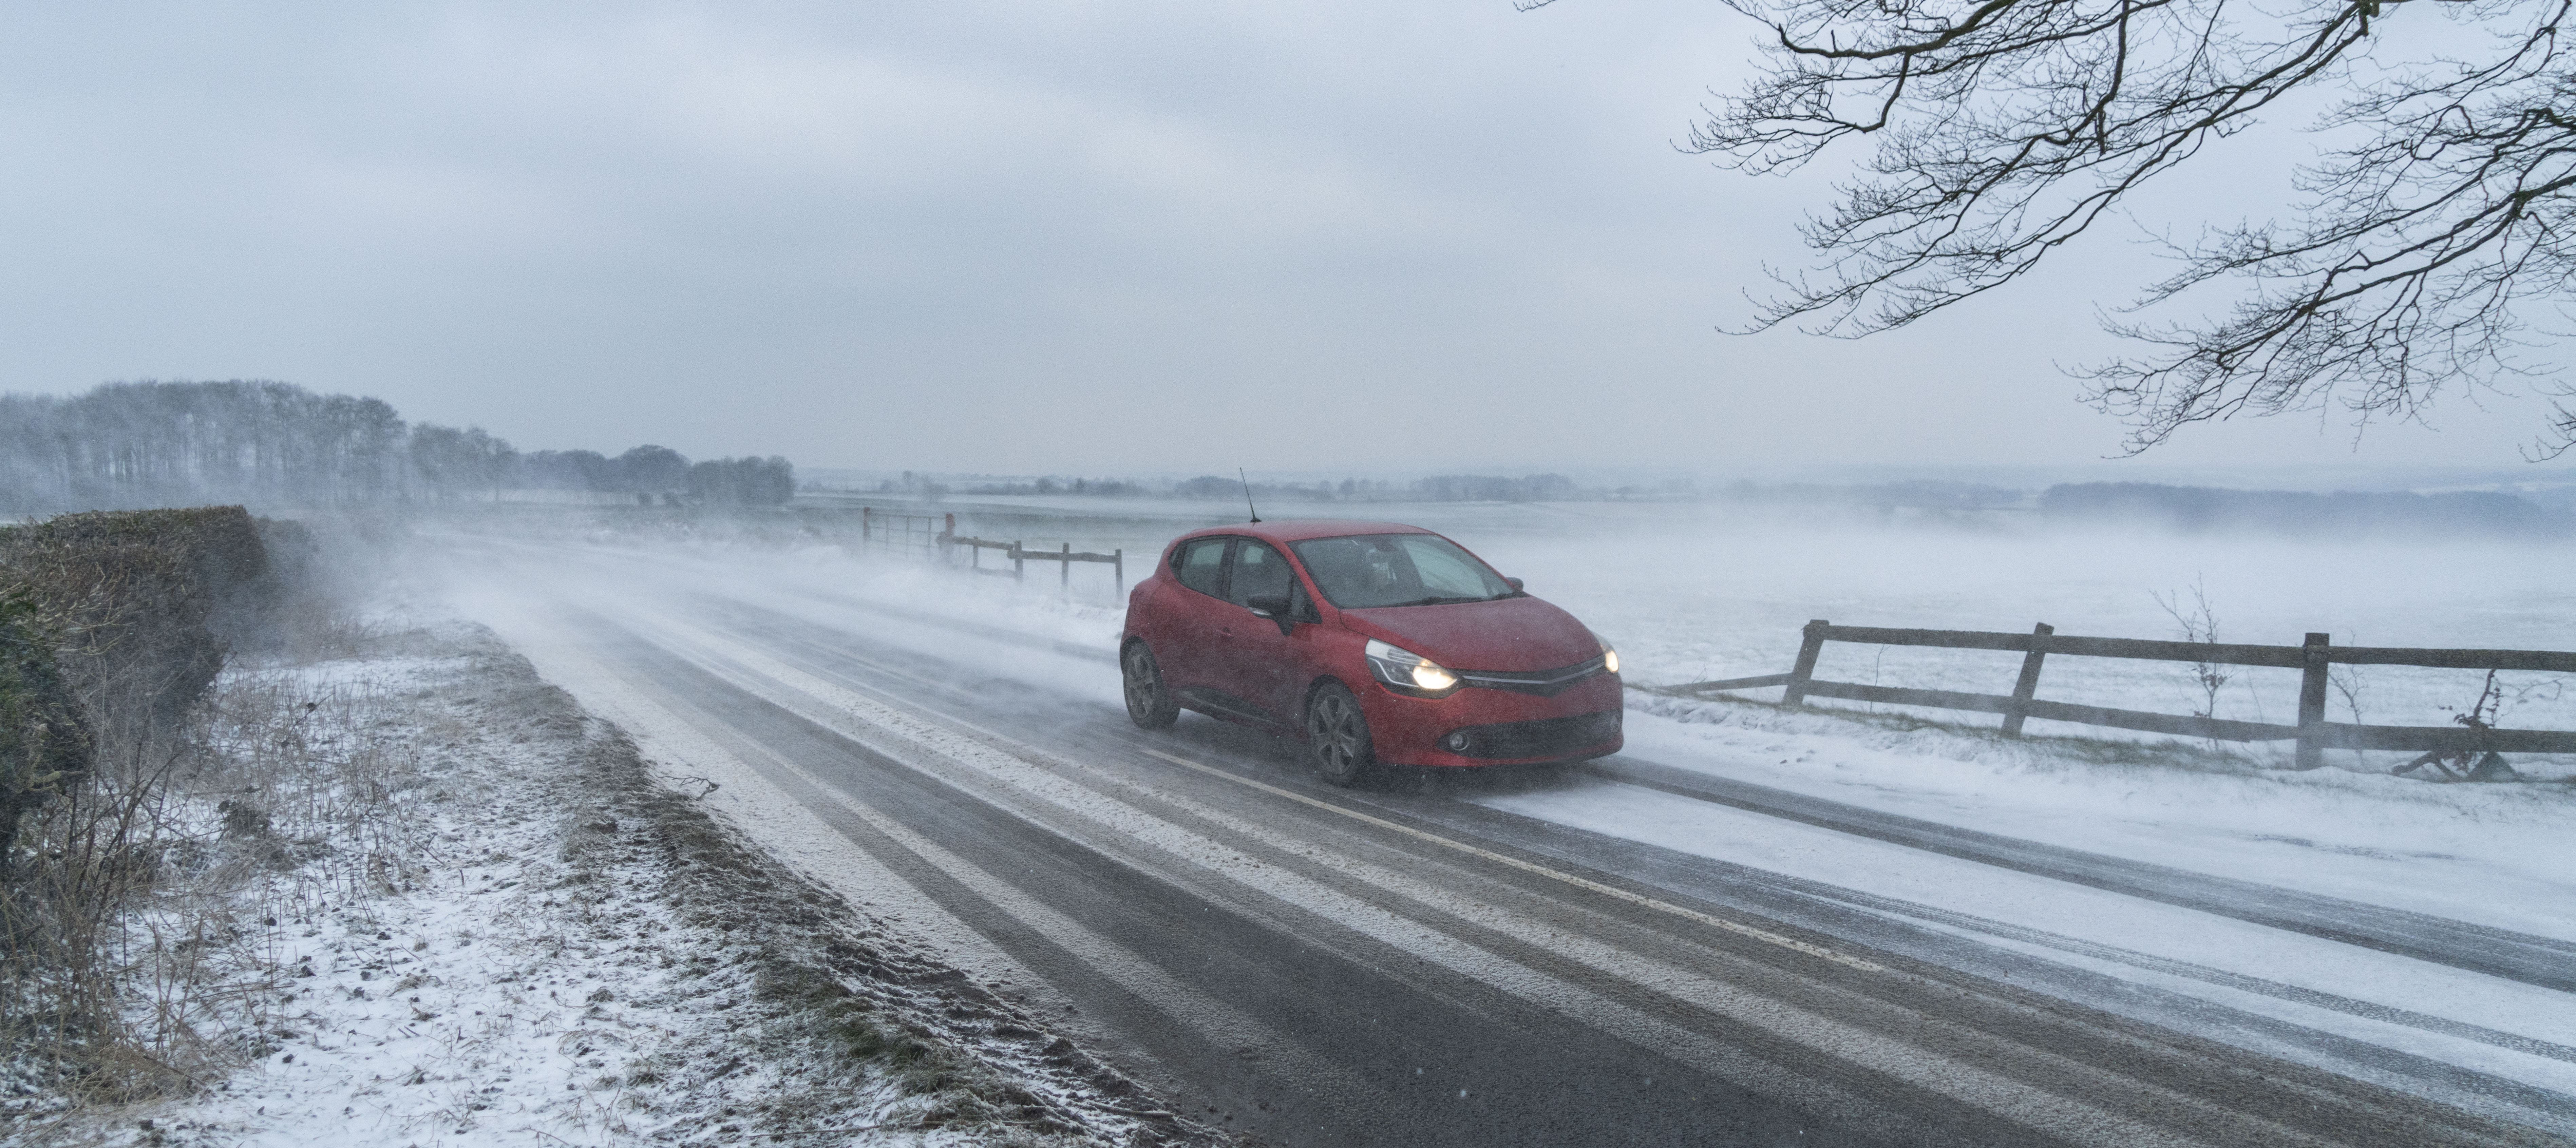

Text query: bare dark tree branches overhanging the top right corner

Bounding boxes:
[1607,0,2576,456]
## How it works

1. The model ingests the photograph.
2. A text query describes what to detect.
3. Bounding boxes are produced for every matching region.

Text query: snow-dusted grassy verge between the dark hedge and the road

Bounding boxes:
[27,623,1216,1148]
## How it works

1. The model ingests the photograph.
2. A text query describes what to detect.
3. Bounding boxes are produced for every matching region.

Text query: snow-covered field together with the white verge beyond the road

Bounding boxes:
[487,504,2576,937]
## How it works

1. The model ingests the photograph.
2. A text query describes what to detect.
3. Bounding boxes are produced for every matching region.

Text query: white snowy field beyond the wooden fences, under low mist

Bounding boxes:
[523,497,2576,777]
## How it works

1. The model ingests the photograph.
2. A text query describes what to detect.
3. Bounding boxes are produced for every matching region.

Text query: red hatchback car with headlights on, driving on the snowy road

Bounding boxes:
[1118,520,1620,785]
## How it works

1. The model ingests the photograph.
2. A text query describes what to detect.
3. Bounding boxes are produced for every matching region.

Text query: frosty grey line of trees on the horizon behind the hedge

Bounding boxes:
[0,381,796,515]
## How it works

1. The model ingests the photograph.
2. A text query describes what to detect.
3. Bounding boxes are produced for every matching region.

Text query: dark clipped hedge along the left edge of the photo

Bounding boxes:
[0,507,301,1117]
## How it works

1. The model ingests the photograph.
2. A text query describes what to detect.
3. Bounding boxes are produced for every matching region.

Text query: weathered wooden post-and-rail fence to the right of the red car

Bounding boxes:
[1662,618,2576,770]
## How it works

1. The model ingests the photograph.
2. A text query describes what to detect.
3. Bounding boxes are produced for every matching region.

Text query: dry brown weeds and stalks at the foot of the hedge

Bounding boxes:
[0,623,420,1122]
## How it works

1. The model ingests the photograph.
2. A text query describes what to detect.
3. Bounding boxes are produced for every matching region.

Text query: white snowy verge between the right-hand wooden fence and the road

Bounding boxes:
[1597,695,2576,939]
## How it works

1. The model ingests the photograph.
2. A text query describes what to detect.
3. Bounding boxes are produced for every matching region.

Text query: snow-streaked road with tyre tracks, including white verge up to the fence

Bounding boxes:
[433,543,2576,1145]
